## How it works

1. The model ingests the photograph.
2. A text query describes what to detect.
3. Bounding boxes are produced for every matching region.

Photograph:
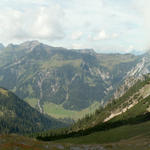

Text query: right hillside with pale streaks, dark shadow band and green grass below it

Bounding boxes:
[35,75,150,146]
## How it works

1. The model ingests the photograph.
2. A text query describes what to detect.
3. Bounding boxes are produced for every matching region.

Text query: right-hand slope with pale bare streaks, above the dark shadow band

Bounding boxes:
[71,75,150,129]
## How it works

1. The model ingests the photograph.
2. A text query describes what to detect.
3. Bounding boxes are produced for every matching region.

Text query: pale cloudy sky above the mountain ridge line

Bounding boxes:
[0,0,150,53]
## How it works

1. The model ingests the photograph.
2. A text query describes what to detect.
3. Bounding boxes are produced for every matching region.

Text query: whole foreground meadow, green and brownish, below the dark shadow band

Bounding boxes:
[0,124,150,150]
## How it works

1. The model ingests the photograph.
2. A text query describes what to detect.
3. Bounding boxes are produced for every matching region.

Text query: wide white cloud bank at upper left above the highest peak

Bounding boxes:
[0,5,64,42]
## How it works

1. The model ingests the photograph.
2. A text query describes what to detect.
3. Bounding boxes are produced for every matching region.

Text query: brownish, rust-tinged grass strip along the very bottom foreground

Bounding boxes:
[0,134,150,150]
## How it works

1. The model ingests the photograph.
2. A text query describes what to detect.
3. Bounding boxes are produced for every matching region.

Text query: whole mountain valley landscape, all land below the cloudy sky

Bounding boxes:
[0,41,150,150]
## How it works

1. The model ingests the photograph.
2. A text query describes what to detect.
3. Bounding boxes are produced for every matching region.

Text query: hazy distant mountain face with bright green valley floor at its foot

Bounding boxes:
[0,41,141,120]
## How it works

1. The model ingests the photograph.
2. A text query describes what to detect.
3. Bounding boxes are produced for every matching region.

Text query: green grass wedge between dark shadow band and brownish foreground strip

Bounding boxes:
[57,121,150,144]
